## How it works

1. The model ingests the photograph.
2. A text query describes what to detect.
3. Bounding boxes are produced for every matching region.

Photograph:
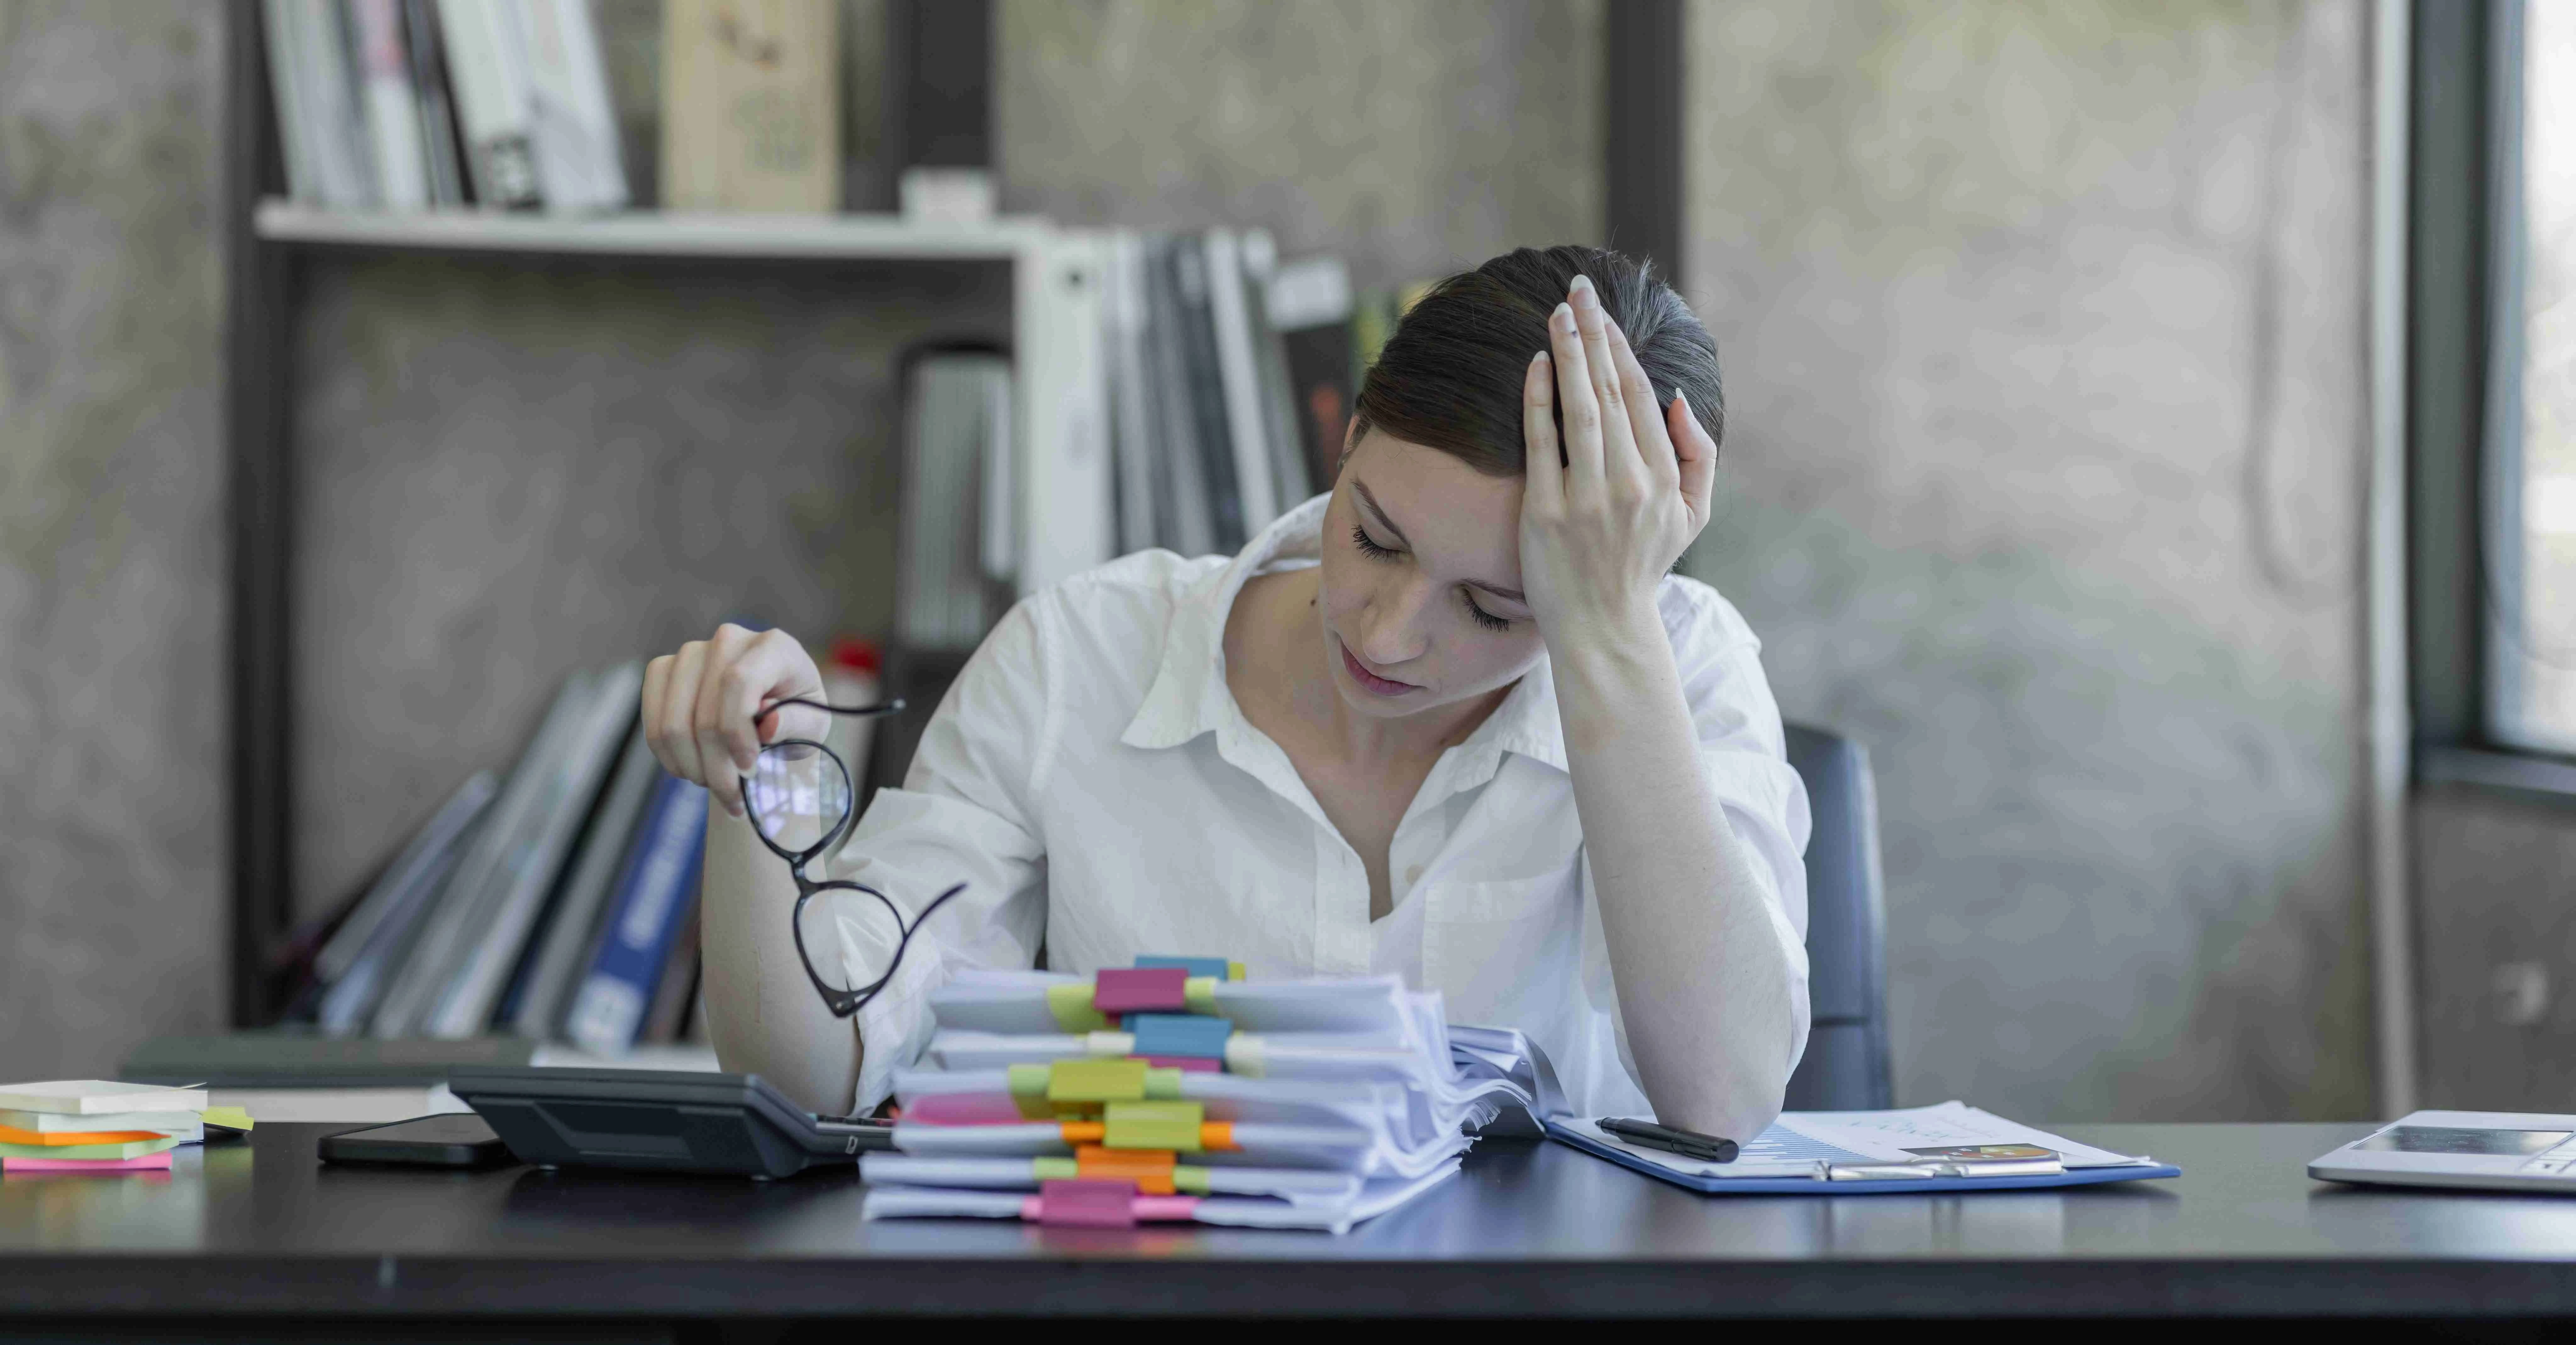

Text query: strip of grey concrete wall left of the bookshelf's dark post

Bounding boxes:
[0,0,224,1080]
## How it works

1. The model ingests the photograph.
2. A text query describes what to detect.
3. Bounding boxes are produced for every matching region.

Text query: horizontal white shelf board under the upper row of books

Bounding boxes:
[253,198,1061,260]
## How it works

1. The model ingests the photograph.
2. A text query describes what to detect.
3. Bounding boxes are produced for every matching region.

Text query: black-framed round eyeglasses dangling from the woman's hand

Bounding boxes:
[742,696,966,1018]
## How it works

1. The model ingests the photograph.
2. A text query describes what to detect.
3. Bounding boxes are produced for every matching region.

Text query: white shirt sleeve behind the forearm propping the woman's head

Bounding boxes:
[1582,580,1813,1087]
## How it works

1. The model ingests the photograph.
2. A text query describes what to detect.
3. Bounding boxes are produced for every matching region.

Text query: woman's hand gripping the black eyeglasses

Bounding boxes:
[644,624,824,817]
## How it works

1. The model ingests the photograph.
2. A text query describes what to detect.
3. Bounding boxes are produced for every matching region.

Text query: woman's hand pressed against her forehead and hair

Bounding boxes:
[1520,276,1718,644]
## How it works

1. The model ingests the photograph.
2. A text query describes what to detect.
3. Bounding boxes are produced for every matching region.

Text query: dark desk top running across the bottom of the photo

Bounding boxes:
[0,1126,2576,1317]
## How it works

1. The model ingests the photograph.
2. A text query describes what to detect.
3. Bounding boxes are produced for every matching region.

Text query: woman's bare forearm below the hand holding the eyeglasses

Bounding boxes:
[698,804,860,1116]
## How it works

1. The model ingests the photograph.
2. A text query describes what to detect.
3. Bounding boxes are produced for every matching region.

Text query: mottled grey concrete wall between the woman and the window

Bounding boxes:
[1687,0,2370,1121]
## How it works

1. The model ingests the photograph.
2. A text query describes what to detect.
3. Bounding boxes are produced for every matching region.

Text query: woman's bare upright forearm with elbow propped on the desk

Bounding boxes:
[1551,608,1796,1139]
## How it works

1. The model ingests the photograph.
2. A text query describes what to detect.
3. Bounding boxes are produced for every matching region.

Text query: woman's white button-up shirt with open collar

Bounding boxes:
[840,497,1808,1116]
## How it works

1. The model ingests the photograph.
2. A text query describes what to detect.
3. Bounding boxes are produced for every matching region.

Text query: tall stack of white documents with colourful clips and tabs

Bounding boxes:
[860,959,1538,1231]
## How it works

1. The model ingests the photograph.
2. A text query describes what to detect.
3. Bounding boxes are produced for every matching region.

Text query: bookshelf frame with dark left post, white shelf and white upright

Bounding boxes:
[224,0,1115,1025]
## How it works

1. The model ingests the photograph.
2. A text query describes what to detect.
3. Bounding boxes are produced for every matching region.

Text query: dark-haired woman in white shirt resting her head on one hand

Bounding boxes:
[644,247,1808,1139]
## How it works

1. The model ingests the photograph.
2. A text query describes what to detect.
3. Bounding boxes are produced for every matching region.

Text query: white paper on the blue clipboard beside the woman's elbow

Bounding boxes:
[1558,1103,2138,1180]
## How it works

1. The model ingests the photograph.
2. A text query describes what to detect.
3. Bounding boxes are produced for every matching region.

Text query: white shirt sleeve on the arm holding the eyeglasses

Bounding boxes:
[832,598,1054,1113]
